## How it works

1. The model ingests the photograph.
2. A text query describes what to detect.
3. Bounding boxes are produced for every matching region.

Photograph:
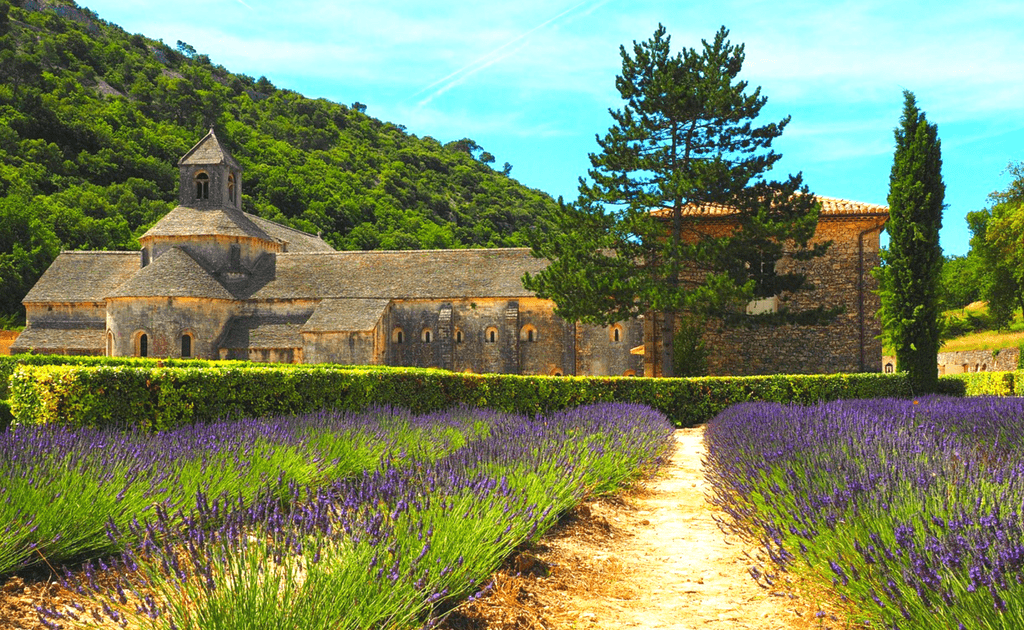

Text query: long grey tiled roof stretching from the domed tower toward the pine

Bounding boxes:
[252,248,548,299]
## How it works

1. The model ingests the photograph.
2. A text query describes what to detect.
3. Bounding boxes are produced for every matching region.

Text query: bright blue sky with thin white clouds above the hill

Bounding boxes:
[82,0,1024,254]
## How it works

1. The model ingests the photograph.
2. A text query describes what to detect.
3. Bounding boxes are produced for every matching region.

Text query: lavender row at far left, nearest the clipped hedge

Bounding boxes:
[0,409,486,576]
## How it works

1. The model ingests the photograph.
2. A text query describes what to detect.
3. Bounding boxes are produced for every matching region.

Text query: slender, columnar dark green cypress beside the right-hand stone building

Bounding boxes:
[881,91,945,393]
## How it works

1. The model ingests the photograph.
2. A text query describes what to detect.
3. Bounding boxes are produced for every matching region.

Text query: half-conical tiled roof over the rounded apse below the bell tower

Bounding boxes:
[108,247,236,300]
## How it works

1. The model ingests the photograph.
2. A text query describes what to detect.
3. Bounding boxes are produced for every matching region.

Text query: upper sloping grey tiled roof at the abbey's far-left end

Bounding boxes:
[22,251,141,304]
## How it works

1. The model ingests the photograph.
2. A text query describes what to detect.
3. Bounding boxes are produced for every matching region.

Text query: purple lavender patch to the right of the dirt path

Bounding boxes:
[706,397,1024,630]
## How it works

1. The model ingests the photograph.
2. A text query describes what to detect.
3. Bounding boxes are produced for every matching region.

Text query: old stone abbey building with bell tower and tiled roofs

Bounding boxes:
[11,131,888,376]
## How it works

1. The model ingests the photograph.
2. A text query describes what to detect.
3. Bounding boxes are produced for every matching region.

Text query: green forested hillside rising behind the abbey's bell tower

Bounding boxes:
[0,0,554,320]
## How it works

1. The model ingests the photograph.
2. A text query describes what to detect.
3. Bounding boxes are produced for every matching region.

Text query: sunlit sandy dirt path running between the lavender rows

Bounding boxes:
[443,428,835,630]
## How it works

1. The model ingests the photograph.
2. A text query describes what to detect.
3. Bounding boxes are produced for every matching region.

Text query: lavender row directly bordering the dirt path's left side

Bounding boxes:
[43,405,673,630]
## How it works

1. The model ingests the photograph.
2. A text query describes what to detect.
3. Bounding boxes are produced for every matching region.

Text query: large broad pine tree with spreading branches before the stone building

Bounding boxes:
[524,25,823,376]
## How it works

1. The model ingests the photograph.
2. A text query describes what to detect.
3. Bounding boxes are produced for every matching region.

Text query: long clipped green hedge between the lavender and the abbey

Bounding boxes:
[10,364,909,429]
